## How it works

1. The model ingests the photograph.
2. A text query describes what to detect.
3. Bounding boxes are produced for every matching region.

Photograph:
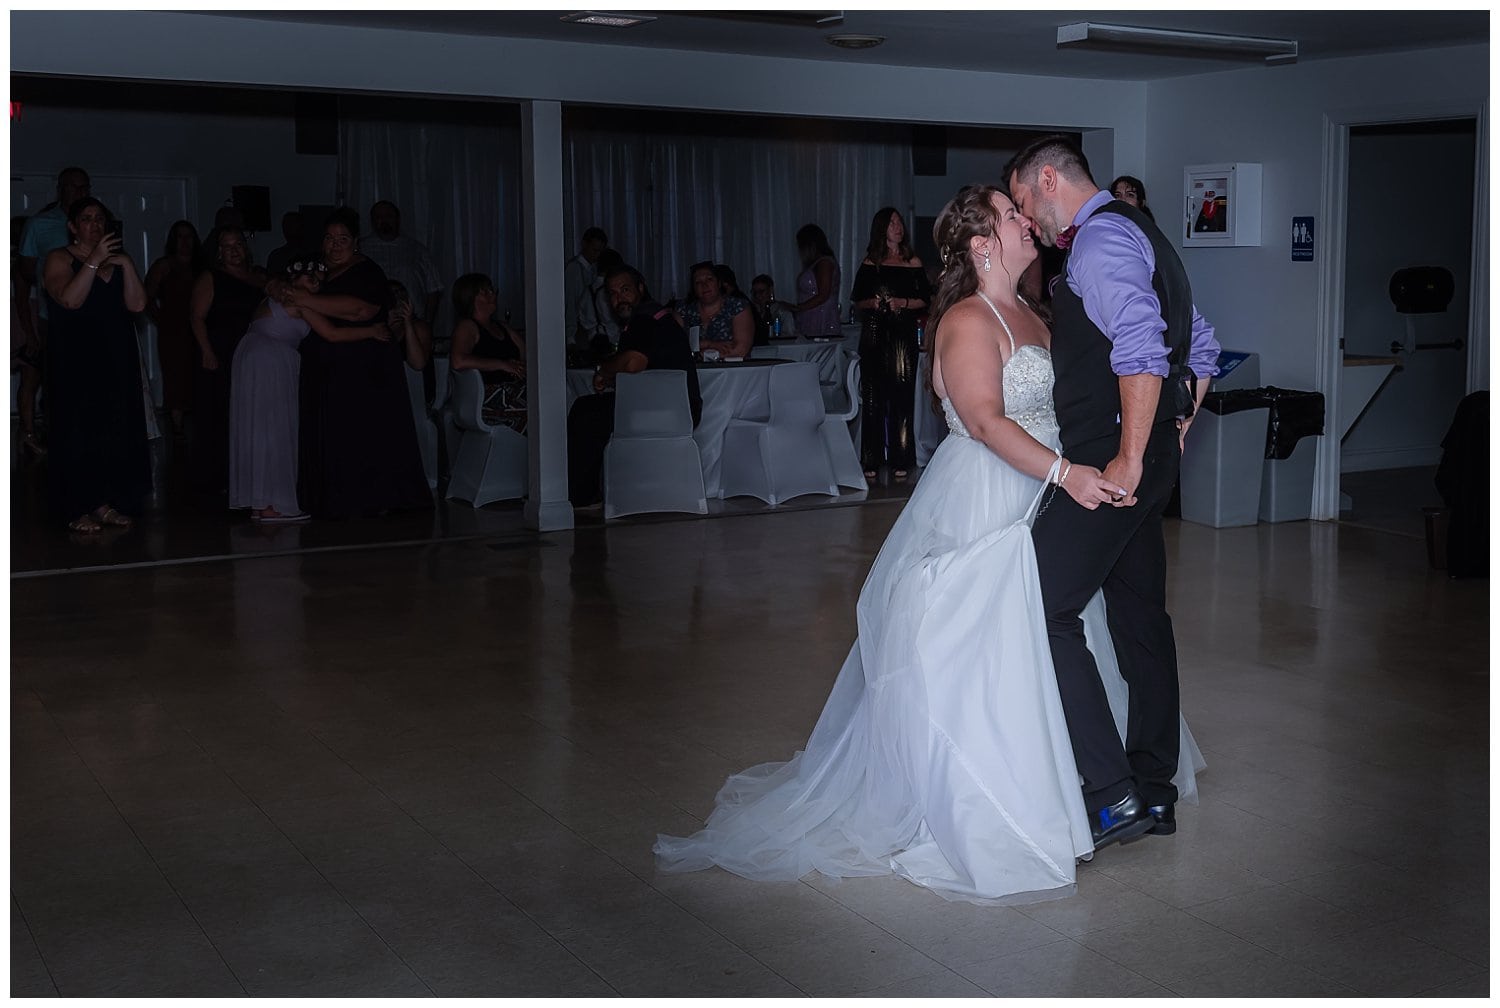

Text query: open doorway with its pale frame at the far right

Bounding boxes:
[1313,108,1488,525]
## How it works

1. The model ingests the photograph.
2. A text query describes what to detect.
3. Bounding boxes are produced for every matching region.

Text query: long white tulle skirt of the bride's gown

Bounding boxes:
[654,437,1203,903]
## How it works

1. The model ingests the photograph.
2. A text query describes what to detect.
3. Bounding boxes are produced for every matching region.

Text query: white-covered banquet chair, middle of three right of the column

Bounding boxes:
[719,362,839,507]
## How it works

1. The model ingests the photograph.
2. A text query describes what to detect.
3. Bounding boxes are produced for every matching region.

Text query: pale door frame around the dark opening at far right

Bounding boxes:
[1311,101,1490,521]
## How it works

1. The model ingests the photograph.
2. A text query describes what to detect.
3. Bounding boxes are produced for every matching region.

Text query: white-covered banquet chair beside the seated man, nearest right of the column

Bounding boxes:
[603,371,708,521]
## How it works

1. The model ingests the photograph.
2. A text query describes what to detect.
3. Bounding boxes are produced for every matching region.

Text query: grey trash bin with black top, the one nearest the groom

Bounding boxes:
[1179,389,1271,528]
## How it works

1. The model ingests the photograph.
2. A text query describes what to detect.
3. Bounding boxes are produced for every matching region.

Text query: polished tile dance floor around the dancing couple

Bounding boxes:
[11,462,1490,996]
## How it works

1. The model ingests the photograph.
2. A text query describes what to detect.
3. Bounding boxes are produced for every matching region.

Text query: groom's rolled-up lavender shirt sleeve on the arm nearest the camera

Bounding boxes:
[1068,216,1170,378]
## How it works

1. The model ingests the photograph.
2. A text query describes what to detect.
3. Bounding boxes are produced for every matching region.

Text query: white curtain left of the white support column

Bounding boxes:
[339,99,525,347]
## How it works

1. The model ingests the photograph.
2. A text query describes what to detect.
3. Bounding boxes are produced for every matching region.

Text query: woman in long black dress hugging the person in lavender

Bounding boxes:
[279,209,432,518]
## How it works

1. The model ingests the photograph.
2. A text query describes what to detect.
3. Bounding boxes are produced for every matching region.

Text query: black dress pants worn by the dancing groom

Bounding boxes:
[1032,420,1181,813]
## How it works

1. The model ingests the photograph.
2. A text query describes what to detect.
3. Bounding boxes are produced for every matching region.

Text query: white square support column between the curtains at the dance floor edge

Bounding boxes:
[521,101,573,533]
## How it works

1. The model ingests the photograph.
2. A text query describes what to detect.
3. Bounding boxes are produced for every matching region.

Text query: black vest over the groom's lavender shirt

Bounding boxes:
[1052,200,1194,453]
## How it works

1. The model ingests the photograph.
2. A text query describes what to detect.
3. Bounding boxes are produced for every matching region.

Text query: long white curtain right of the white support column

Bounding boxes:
[563,110,912,318]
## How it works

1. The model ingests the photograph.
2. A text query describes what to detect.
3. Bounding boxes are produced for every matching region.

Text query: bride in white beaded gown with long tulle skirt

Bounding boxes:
[654,186,1202,903]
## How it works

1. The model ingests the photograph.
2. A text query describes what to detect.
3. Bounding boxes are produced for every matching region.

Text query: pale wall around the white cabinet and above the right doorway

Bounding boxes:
[1140,45,1490,389]
